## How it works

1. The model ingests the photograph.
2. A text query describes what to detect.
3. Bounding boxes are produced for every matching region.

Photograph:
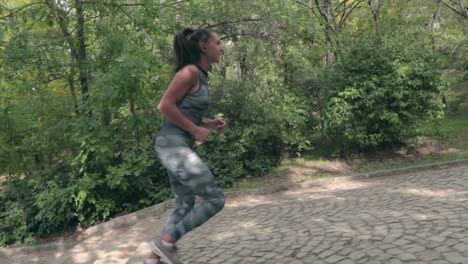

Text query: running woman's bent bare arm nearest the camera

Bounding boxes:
[157,65,210,142]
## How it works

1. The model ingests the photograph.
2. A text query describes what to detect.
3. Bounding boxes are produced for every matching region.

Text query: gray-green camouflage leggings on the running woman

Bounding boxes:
[155,135,224,240]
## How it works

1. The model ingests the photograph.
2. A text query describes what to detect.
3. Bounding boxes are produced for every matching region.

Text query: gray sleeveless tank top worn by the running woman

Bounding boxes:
[158,66,211,141]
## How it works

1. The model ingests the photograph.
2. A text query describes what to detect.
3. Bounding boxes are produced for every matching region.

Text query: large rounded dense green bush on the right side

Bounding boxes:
[323,38,444,152]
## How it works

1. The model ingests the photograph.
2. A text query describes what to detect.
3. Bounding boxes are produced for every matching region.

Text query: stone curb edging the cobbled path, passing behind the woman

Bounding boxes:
[0,159,468,257]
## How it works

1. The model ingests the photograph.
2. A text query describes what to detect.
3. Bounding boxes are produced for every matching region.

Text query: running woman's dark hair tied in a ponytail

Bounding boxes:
[174,28,213,72]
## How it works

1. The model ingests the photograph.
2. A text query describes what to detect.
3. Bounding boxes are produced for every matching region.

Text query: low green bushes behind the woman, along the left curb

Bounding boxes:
[0,111,170,245]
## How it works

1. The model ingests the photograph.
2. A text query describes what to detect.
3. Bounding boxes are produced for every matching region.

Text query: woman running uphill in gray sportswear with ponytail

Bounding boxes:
[144,28,226,264]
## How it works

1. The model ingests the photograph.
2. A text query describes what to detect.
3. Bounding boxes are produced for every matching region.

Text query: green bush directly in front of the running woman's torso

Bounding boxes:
[197,81,315,187]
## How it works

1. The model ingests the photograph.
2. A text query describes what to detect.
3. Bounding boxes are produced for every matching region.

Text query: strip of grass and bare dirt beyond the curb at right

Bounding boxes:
[226,75,468,191]
